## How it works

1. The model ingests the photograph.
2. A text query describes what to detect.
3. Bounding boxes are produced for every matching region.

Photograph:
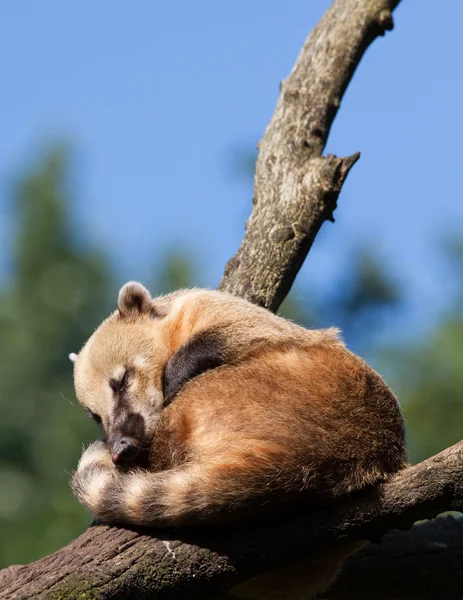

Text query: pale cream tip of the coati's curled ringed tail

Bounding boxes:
[72,440,117,514]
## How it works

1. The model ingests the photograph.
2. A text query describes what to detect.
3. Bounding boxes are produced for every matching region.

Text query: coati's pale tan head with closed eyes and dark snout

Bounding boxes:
[70,282,174,464]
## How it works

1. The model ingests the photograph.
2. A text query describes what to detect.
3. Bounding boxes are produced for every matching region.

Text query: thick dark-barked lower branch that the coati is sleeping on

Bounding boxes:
[0,442,463,600]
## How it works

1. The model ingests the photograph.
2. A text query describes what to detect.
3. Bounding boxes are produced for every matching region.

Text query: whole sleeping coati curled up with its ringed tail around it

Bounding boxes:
[72,282,406,596]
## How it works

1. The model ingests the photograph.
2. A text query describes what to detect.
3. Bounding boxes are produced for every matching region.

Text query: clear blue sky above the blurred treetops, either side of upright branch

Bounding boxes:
[0,0,463,328]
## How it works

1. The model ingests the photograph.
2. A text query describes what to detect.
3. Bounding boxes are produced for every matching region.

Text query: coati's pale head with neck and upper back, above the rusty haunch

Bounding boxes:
[70,282,286,464]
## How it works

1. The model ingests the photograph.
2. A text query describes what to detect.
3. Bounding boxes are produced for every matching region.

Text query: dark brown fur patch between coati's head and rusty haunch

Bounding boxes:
[163,331,228,406]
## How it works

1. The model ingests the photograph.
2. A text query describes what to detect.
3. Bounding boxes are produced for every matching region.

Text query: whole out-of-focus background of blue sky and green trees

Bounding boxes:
[0,0,463,566]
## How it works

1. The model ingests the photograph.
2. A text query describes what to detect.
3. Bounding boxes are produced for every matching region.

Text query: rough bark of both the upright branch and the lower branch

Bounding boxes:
[5,0,463,600]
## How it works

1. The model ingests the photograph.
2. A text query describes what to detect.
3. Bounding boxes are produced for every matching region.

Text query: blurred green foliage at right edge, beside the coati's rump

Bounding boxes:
[380,241,463,463]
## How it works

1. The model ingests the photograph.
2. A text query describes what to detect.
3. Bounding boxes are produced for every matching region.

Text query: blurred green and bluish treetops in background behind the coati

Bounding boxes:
[0,148,463,567]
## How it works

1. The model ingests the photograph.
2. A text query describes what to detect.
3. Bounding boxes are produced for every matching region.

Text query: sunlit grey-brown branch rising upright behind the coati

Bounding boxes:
[219,0,399,311]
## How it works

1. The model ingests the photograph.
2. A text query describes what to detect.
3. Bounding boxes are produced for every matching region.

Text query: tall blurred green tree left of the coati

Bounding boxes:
[0,148,112,566]
